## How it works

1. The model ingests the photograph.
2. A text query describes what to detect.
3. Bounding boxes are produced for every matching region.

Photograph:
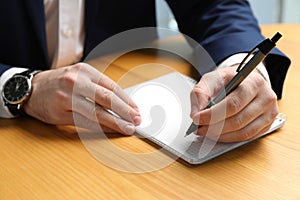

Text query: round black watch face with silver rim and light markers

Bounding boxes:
[2,76,30,104]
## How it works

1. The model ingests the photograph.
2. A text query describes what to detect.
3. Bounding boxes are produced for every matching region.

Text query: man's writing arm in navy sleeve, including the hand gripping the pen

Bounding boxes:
[168,0,290,142]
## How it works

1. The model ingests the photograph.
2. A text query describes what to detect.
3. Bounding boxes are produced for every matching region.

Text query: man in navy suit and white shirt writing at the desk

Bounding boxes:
[0,0,290,142]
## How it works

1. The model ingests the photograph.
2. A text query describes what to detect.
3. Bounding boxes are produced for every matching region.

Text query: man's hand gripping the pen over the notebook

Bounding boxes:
[191,67,278,142]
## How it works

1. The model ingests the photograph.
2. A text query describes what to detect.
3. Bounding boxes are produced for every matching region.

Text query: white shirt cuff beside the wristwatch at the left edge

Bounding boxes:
[0,67,27,118]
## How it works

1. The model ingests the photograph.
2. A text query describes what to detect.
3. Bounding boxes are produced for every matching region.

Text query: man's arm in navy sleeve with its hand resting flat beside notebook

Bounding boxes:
[0,1,140,134]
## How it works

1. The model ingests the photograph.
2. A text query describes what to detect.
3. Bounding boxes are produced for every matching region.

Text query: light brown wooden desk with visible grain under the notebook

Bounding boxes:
[0,25,300,199]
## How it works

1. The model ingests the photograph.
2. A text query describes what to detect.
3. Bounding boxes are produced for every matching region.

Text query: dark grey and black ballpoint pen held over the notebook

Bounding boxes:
[185,32,282,137]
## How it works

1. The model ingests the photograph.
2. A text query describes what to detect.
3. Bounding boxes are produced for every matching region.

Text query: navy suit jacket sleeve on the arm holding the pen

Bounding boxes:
[167,0,290,99]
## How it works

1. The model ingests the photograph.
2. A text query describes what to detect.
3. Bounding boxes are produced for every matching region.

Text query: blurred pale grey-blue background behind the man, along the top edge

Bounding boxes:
[156,0,300,33]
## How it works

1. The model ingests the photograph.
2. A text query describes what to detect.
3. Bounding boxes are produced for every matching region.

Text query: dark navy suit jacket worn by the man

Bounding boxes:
[0,0,290,98]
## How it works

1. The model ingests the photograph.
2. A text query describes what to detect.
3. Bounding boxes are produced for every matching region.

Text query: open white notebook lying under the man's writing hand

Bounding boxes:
[125,72,285,164]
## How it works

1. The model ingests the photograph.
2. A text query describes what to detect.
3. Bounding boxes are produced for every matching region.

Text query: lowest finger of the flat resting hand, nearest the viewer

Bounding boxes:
[74,97,135,135]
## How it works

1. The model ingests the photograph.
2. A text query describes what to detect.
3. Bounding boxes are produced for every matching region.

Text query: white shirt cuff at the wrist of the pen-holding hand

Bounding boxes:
[218,53,271,85]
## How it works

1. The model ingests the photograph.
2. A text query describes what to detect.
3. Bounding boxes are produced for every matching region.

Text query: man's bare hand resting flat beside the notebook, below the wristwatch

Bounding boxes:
[24,63,141,135]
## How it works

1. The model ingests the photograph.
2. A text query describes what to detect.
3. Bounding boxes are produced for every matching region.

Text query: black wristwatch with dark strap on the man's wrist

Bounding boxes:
[2,69,40,116]
